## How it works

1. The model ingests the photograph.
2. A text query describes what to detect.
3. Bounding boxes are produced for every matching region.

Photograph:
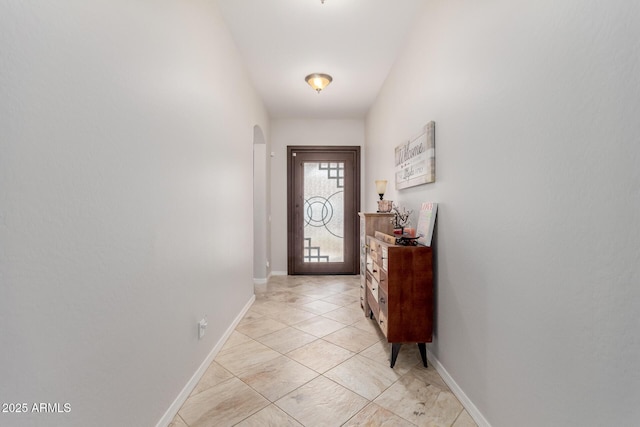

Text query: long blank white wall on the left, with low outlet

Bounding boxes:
[0,0,268,426]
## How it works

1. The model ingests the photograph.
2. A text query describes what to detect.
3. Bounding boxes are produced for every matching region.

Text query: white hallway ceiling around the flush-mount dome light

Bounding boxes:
[217,0,425,118]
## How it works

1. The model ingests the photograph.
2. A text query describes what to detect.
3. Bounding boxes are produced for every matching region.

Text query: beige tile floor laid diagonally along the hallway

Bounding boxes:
[170,276,476,427]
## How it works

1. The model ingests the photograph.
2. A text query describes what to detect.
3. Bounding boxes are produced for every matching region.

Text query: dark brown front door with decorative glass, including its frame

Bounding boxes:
[287,146,360,274]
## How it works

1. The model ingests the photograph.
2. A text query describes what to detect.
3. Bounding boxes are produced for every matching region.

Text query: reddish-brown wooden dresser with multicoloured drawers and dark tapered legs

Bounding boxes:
[361,213,434,368]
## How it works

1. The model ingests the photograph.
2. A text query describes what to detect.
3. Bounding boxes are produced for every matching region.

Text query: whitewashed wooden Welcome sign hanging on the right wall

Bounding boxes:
[395,121,436,190]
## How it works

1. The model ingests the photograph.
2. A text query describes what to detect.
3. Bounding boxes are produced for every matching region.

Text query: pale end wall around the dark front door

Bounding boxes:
[270,119,364,274]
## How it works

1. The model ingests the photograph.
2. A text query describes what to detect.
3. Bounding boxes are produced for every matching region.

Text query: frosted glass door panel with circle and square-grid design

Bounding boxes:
[302,162,344,262]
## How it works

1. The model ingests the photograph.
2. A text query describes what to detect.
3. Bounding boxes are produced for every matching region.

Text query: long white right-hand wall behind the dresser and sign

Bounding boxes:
[364,0,640,426]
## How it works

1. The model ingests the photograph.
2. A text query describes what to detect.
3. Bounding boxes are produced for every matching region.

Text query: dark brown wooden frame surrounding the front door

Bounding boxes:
[287,145,362,275]
